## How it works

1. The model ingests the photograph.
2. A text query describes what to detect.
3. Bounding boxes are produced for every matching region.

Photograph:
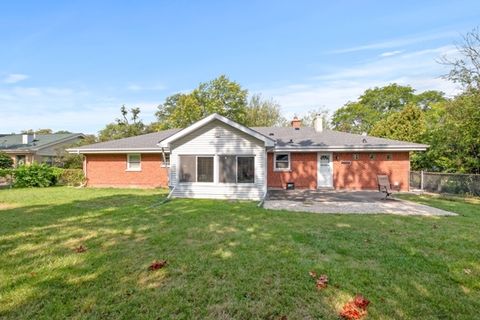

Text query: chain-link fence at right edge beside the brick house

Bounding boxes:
[410,171,480,196]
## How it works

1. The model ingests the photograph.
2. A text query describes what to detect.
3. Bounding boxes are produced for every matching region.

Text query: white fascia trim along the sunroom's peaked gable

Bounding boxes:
[157,113,275,148]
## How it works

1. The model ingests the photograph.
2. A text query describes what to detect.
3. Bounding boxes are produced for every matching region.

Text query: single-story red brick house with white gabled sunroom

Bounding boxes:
[68,114,427,199]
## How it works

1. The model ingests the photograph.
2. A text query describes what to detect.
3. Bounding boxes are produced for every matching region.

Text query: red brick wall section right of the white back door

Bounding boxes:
[333,152,410,191]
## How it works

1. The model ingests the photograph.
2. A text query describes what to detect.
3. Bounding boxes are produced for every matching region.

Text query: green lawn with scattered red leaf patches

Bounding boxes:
[0,187,480,319]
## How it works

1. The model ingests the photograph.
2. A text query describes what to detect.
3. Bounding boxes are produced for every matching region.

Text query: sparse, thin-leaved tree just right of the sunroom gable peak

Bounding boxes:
[244,94,287,127]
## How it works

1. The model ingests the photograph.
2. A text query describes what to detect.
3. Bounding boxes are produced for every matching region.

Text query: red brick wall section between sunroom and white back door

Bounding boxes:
[267,152,317,189]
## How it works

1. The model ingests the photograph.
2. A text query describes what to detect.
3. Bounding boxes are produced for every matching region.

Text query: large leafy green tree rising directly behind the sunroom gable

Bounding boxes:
[152,75,248,130]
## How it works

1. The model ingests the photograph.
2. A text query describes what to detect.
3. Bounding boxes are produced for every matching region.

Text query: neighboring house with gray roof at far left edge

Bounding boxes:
[0,133,84,166]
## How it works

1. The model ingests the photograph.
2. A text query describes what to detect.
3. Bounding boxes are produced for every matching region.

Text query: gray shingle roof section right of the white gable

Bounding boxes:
[252,127,427,148]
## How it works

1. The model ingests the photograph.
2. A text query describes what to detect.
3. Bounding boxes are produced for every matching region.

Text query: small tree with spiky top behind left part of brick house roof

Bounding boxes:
[98,105,148,141]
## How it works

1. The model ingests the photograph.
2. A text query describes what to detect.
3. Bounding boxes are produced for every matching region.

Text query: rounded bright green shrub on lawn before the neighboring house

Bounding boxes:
[13,163,58,188]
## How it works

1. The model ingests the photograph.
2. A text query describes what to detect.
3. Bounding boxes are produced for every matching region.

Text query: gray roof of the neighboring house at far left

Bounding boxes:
[0,133,84,152]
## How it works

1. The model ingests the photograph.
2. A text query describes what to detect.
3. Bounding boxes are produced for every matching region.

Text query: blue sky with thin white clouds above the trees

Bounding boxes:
[0,1,480,133]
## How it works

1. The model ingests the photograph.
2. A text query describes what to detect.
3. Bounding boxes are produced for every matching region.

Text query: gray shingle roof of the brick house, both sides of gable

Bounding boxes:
[69,127,427,152]
